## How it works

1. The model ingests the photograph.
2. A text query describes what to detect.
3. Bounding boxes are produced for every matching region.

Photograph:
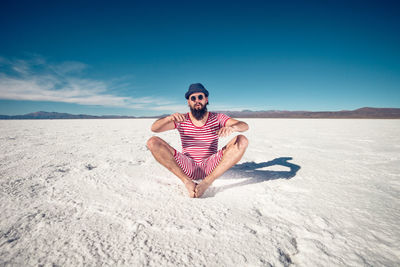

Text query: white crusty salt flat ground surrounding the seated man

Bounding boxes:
[0,119,400,266]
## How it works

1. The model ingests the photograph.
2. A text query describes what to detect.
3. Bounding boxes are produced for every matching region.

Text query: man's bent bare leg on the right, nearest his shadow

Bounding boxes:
[195,135,249,197]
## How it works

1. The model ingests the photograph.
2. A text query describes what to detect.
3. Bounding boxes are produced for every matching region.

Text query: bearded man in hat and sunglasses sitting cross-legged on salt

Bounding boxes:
[147,83,249,197]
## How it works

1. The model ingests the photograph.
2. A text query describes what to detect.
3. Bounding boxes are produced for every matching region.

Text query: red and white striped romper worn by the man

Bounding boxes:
[174,112,230,179]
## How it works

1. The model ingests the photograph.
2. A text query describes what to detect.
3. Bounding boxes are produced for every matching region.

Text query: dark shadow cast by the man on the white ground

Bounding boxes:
[207,157,301,196]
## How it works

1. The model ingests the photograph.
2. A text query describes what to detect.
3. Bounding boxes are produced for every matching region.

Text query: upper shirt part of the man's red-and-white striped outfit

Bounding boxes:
[175,112,230,163]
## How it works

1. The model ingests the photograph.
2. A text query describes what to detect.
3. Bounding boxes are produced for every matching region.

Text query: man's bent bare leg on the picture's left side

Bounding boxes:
[147,136,196,197]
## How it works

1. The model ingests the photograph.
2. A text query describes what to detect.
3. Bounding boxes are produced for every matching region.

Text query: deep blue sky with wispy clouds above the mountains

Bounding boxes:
[0,0,400,116]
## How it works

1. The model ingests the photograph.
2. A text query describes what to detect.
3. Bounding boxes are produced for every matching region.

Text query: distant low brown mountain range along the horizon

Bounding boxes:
[0,107,400,120]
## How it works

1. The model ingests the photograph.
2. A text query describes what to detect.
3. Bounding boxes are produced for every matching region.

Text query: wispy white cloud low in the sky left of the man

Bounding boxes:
[0,57,182,111]
